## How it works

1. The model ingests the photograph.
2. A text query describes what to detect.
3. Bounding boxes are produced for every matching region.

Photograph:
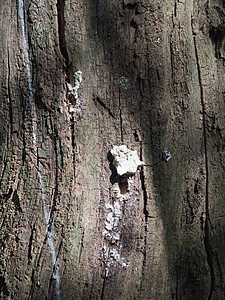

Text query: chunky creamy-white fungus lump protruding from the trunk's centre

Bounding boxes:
[111,145,143,176]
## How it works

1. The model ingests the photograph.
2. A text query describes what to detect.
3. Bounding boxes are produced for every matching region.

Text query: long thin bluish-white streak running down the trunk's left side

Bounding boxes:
[18,0,61,300]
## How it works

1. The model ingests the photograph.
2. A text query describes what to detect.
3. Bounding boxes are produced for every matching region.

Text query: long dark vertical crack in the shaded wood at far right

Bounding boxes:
[191,23,215,300]
